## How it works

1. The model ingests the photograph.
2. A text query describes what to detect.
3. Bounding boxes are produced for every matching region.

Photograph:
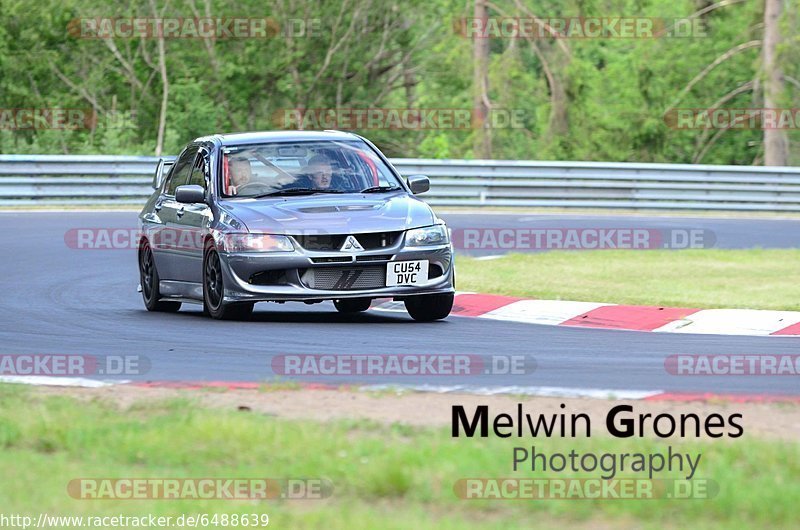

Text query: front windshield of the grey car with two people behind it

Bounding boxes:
[221,140,402,198]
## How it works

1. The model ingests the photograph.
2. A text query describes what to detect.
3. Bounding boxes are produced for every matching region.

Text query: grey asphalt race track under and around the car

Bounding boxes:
[0,208,800,394]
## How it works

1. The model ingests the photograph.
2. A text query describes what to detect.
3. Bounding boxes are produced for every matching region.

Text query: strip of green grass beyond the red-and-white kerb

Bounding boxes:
[456,249,800,310]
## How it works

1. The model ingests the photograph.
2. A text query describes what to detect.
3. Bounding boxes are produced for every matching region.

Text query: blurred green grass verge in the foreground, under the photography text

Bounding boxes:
[0,385,800,530]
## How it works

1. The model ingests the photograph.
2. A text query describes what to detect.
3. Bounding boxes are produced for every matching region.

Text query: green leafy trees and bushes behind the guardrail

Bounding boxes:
[0,0,800,164]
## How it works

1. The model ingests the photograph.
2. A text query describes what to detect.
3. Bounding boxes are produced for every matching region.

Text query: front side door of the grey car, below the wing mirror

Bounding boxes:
[174,147,213,284]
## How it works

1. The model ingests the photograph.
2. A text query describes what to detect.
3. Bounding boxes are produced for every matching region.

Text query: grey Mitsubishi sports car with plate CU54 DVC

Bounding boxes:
[138,131,455,321]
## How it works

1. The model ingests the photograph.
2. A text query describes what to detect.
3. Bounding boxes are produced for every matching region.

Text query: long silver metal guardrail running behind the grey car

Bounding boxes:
[0,155,800,212]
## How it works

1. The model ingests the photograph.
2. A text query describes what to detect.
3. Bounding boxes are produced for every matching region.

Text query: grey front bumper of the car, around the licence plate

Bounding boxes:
[220,240,455,302]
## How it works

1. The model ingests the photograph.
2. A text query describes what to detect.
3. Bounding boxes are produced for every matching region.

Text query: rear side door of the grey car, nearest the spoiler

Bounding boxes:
[153,145,198,280]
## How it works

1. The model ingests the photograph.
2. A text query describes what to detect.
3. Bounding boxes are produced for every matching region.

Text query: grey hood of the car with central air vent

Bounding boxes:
[220,192,436,235]
